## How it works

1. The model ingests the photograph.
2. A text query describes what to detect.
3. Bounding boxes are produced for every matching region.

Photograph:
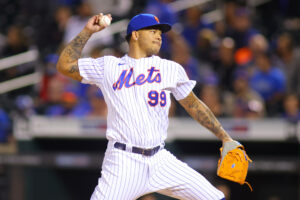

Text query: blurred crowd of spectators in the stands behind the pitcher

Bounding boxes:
[0,0,300,142]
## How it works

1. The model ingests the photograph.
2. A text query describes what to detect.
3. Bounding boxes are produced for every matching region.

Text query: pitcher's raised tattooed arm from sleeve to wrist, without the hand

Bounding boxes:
[57,30,91,81]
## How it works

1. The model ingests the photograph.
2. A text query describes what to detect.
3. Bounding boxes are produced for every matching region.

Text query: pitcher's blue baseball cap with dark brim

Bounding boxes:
[126,13,172,38]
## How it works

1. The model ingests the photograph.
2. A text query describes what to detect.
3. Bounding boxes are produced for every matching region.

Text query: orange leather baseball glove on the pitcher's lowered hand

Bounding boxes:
[217,146,253,191]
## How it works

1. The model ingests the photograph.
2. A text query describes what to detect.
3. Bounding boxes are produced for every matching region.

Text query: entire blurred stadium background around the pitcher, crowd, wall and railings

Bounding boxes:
[0,0,300,200]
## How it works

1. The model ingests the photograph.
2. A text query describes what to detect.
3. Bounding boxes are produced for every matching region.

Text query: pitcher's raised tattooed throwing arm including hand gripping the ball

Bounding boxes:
[56,13,111,81]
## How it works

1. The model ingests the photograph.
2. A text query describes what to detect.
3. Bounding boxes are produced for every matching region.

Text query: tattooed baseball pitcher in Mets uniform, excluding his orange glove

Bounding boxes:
[57,13,246,200]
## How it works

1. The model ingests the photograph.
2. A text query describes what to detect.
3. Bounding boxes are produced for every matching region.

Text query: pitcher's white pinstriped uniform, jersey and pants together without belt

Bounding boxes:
[78,55,224,200]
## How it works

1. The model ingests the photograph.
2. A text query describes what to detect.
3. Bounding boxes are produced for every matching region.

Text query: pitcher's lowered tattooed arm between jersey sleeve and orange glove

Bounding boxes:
[179,92,232,143]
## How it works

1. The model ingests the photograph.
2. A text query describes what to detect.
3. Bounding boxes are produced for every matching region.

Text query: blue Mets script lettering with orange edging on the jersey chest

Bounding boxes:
[113,67,161,90]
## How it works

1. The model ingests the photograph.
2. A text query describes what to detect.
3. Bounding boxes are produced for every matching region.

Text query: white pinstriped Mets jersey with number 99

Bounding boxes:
[78,55,195,148]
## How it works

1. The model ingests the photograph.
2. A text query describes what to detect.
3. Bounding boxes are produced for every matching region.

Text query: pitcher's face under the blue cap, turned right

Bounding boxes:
[137,29,162,56]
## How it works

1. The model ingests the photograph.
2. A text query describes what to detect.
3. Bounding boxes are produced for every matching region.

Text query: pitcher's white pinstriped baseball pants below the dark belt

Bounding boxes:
[91,141,224,200]
